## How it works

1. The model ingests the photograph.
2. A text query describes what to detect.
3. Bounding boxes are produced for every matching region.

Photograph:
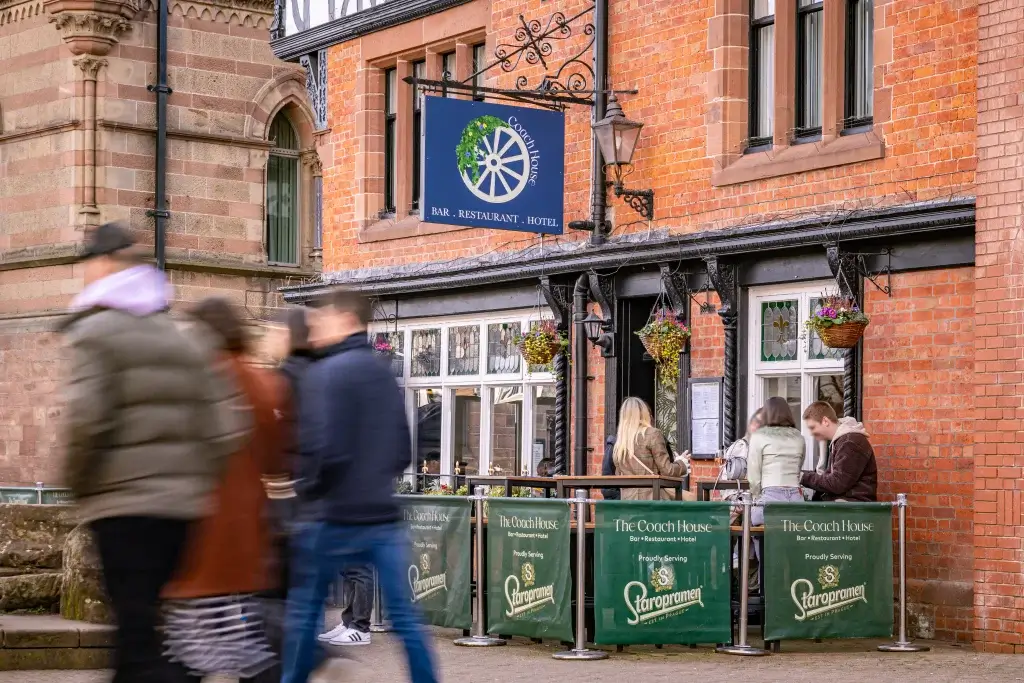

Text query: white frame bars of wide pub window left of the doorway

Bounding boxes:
[369,309,555,484]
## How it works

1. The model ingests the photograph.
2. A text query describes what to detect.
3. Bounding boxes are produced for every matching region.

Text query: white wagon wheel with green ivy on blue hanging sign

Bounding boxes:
[456,116,529,204]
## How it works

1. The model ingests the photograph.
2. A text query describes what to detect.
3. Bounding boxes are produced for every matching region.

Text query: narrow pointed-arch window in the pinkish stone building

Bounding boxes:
[266,112,300,265]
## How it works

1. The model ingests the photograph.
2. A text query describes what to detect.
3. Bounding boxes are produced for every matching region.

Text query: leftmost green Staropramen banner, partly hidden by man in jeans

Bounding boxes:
[402,496,473,629]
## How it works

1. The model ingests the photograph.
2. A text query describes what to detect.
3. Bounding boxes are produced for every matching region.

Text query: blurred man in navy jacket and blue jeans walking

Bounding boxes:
[282,289,437,683]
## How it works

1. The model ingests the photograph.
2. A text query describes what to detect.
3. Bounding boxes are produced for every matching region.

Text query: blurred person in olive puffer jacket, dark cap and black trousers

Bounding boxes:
[60,223,252,683]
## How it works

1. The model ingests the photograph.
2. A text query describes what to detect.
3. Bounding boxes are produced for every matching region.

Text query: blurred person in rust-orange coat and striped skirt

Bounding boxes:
[163,298,287,683]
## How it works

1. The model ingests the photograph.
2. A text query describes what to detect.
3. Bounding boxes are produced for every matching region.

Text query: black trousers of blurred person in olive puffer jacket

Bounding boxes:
[91,517,188,683]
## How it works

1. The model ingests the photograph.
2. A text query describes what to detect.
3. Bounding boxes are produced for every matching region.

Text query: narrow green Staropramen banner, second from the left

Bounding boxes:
[487,498,572,641]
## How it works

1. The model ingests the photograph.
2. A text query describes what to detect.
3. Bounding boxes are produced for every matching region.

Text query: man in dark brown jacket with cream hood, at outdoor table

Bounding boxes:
[800,401,879,502]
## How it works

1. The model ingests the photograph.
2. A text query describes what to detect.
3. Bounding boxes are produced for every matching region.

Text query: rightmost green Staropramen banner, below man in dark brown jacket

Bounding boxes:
[764,503,893,640]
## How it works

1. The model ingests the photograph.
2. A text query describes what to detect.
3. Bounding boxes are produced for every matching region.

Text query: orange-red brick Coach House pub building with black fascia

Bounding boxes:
[272,0,1024,652]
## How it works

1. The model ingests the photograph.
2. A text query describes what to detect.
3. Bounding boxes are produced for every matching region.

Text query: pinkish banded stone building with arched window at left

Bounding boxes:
[0,0,324,485]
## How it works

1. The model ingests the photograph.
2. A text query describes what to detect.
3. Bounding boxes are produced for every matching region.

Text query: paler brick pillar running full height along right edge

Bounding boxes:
[974,0,1024,653]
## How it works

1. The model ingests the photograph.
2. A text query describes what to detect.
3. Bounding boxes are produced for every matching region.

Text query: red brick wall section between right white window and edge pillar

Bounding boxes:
[863,268,976,643]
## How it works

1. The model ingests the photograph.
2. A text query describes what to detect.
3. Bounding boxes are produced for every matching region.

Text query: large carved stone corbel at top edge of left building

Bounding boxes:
[43,0,139,56]
